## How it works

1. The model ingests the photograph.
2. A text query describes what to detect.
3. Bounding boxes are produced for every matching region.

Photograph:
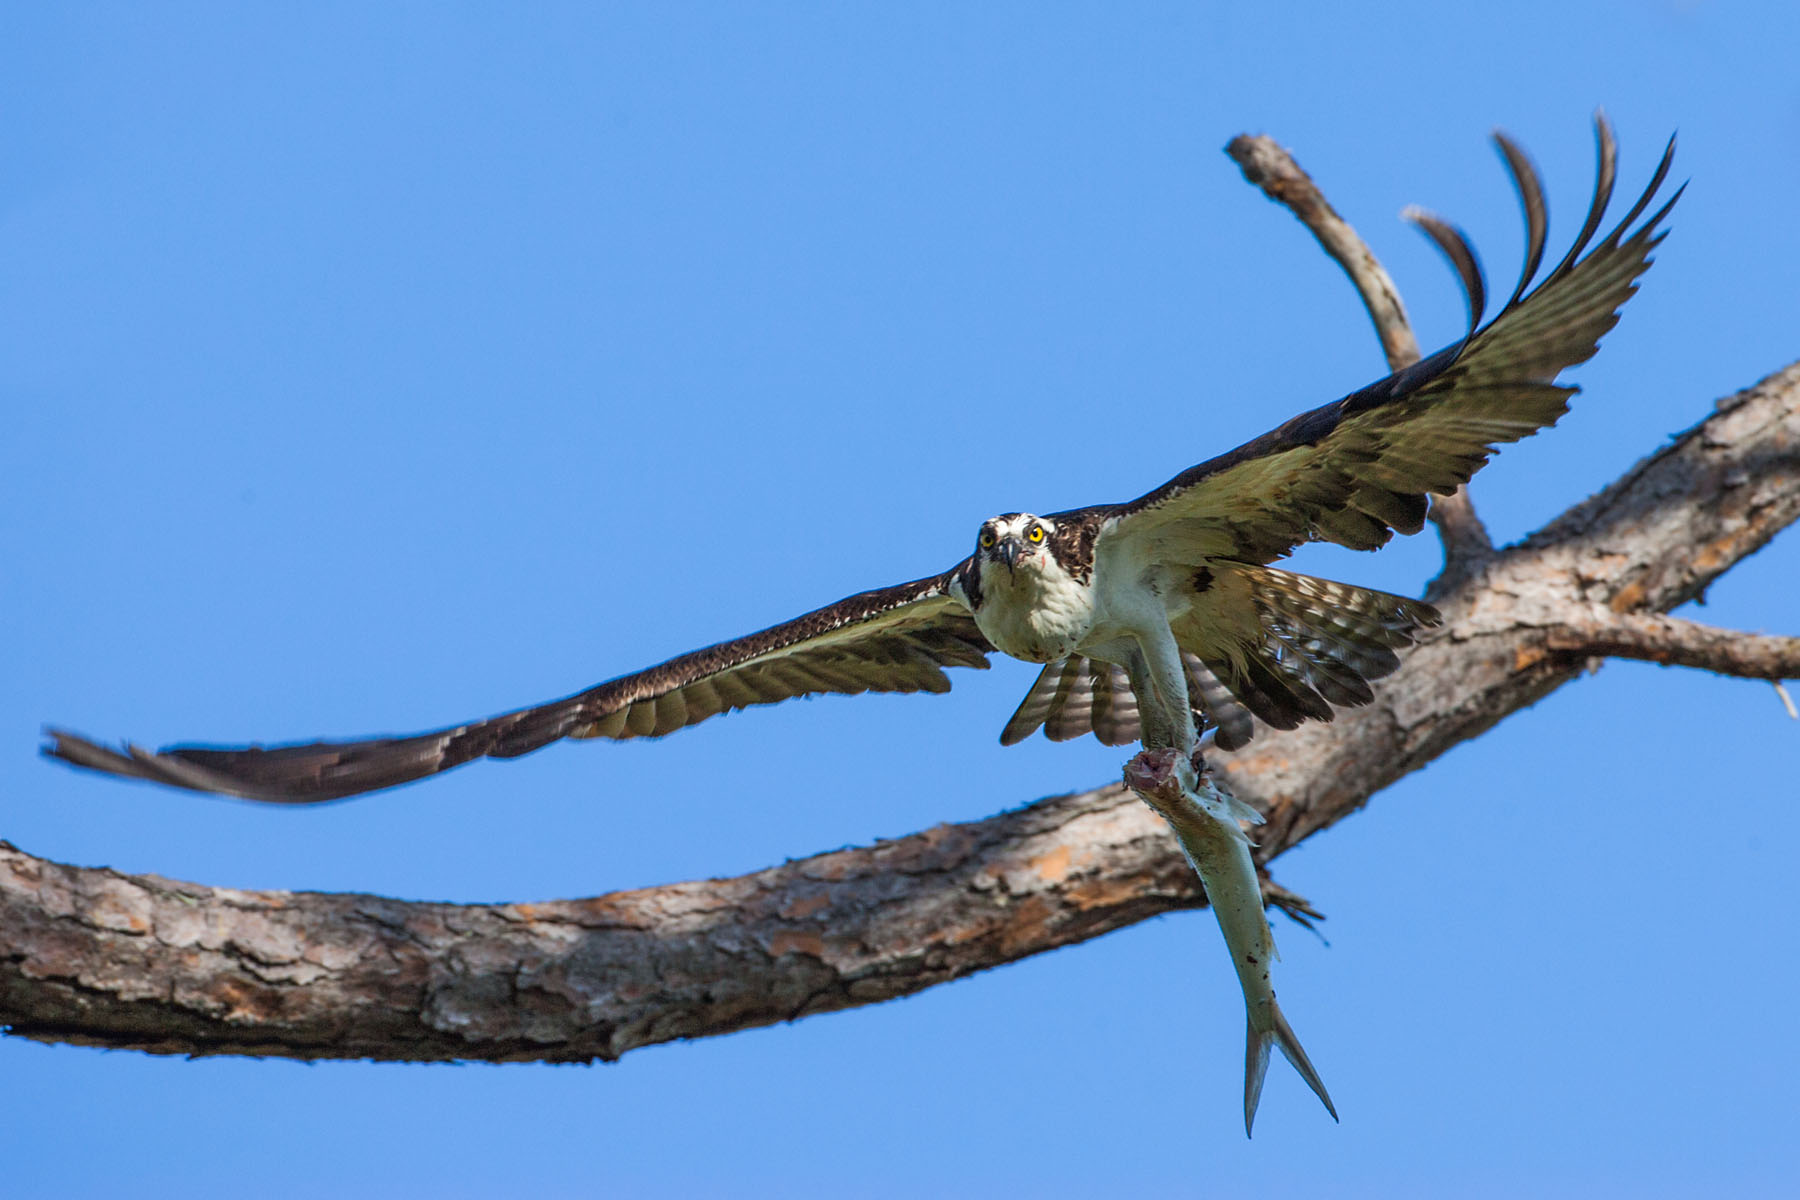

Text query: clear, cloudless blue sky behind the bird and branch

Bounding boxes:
[0,0,1800,1196]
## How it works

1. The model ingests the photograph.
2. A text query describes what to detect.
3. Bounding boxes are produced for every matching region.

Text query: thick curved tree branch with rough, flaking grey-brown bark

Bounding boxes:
[0,139,1800,1061]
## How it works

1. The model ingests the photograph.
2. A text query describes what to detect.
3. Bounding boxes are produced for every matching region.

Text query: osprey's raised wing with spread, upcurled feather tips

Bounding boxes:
[1098,117,1681,563]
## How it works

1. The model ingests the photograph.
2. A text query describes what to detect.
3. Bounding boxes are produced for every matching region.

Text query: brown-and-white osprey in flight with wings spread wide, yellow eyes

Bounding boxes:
[43,117,1679,804]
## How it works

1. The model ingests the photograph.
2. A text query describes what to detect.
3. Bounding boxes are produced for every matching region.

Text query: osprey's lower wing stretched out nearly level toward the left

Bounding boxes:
[43,570,994,804]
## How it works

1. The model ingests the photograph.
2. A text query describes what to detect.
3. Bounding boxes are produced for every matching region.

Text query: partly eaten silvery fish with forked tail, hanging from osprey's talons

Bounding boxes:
[1125,750,1337,1137]
